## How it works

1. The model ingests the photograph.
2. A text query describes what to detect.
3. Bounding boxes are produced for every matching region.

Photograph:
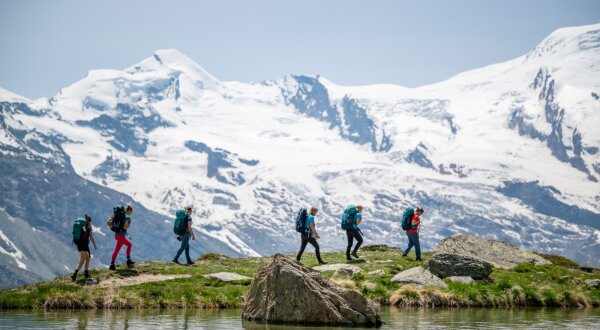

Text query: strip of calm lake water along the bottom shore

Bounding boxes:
[0,307,600,330]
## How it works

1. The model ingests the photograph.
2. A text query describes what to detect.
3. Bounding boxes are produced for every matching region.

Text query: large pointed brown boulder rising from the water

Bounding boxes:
[242,254,383,327]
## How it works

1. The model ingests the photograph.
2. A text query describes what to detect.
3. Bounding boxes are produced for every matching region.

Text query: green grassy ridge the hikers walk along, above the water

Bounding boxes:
[0,245,600,309]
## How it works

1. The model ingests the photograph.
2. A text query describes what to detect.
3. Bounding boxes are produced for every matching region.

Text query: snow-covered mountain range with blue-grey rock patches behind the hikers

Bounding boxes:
[0,24,600,286]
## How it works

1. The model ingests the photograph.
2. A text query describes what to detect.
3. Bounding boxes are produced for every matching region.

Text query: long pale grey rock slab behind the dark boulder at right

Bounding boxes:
[433,235,551,269]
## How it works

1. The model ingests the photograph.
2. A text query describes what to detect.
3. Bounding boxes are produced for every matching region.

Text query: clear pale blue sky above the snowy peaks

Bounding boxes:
[0,0,600,98]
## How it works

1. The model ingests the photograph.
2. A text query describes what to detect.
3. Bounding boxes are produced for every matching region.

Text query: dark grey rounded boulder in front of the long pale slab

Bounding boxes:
[425,253,492,280]
